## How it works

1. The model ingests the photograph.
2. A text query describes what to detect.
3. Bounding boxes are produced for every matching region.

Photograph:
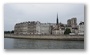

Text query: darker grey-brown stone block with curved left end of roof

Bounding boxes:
[14,21,36,34]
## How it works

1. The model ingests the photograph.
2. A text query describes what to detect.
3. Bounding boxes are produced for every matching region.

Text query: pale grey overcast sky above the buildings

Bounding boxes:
[4,4,84,31]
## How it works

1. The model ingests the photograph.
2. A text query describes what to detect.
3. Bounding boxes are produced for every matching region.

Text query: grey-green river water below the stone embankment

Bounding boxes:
[4,38,84,49]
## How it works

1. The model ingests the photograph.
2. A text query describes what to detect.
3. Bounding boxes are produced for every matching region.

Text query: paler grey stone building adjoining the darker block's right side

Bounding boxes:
[36,22,51,34]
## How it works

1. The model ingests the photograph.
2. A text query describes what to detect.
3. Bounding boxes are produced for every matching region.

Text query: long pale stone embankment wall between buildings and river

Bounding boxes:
[4,34,84,41]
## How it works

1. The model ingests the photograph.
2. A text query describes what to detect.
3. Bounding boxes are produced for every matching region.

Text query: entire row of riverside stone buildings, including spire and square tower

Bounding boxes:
[14,14,84,35]
